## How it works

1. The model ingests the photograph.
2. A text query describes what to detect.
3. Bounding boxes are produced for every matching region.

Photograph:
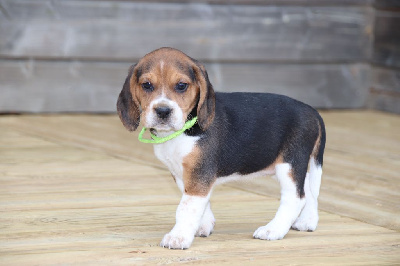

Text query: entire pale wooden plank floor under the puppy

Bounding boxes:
[0,111,400,265]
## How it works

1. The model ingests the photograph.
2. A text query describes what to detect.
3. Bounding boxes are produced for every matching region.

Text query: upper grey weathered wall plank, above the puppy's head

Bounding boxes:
[0,1,372,62]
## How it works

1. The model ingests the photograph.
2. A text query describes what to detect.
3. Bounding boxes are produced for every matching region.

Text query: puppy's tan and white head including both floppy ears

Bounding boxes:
[117,48,215,131]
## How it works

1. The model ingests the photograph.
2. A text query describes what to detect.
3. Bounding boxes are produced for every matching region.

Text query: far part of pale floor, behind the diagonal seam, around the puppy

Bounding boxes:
[3,111,400,230]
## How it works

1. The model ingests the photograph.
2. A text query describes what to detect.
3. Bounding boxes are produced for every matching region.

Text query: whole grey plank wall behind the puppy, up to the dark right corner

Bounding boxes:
[0,0,399,112]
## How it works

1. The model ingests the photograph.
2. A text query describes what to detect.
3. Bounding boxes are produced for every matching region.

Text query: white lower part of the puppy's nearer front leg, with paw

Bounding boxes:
[160,193,211,249]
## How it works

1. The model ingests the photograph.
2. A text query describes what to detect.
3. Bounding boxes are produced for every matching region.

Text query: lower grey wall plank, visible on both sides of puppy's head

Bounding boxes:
[0,60,369,113]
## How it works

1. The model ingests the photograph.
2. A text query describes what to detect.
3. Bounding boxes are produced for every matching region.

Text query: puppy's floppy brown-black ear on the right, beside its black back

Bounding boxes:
[194,60,215,130]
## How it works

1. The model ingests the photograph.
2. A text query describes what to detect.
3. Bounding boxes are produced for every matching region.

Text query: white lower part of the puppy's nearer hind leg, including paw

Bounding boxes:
[253,163,307,240]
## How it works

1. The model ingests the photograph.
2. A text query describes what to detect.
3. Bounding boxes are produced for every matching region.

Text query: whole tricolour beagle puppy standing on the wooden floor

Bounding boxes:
[117,48,326,249]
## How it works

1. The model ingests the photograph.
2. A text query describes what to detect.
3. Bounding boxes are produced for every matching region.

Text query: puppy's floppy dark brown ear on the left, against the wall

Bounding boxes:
[117,65,140,131]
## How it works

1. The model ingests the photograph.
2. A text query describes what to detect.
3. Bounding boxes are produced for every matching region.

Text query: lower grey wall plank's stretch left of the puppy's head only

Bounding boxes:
[0,61,129,112]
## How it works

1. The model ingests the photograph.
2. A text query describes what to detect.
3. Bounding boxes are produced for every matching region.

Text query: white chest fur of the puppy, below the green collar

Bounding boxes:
[154,134,199,183]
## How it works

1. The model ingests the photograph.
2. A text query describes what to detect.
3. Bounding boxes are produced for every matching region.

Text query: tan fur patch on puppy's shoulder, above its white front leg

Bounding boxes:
[182,146,215,197]
